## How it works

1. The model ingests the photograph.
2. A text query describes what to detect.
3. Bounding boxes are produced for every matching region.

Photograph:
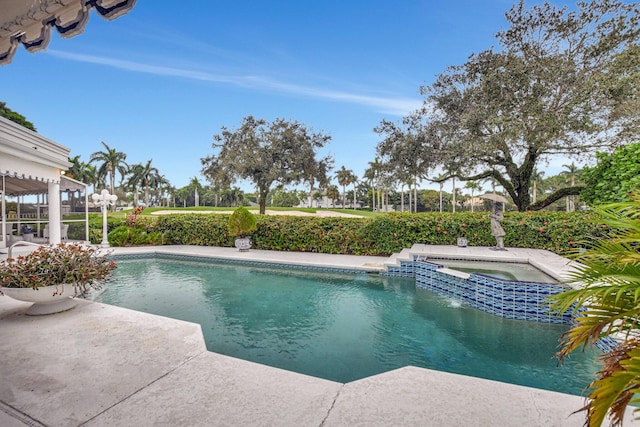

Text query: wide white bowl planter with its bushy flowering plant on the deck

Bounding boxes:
[0,243,116,315]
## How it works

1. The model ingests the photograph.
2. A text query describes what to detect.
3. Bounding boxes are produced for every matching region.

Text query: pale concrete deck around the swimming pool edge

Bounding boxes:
[0,246,640,427]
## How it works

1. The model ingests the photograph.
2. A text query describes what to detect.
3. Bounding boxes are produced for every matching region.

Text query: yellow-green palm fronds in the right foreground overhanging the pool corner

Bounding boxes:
[551,195,640,426]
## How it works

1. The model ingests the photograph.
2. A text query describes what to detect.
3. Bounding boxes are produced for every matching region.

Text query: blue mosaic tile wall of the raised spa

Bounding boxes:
[385,260,572,324]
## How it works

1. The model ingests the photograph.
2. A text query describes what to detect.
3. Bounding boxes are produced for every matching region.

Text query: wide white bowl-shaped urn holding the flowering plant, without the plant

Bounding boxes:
[0,285,77,316]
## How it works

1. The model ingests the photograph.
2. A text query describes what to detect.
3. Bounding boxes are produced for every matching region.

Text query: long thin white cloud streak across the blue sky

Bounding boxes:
[48,49,422,116]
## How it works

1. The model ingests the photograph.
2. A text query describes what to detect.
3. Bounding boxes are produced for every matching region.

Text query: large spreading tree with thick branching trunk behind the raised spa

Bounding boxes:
[402,0,640,211]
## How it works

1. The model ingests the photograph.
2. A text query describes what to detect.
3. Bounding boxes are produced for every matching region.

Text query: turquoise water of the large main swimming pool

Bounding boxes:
[95,258,599,394]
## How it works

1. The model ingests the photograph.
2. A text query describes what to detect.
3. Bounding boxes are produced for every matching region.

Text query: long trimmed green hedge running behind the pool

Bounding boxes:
[148,212,607,256]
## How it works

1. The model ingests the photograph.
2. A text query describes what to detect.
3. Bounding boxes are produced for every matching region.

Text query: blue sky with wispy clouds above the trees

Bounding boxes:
[0,0,571,191]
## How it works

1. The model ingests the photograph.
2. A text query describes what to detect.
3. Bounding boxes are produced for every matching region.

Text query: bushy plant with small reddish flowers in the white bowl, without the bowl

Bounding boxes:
[0,243,116,296]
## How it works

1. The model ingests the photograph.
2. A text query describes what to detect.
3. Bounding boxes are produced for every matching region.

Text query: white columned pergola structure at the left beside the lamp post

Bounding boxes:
[0,117,89,247]
